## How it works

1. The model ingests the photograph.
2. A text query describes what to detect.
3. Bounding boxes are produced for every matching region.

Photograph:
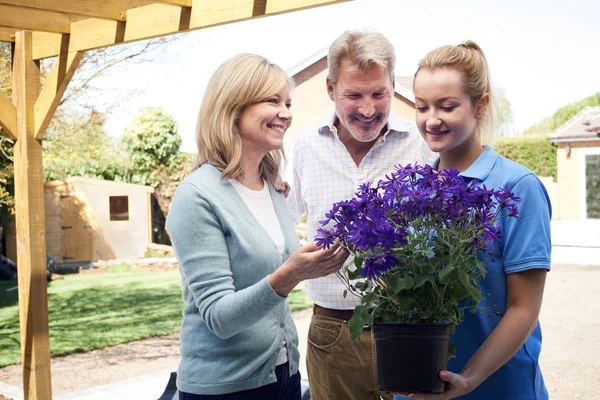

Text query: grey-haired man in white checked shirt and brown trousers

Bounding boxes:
[286,31,433,400]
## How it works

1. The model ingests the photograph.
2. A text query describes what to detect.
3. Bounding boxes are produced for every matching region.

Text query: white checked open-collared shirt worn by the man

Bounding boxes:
[285,112,434,310]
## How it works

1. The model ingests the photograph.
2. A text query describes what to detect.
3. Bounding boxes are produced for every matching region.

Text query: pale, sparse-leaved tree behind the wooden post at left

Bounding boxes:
[0,37,175,223]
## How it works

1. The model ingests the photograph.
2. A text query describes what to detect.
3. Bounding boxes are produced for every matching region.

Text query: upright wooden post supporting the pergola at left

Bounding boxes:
[13,31,52,400]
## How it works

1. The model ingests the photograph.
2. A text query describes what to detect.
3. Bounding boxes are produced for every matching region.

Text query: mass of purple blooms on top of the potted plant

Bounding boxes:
[315,164,520,290]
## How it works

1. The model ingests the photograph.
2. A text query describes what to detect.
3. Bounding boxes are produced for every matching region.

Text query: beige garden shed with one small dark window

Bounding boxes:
[6,177,154,263]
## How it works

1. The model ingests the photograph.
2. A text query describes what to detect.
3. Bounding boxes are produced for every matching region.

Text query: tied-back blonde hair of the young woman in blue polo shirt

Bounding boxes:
[415,40,494,145]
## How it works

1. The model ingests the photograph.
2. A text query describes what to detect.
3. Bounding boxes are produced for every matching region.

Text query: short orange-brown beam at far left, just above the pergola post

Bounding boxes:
[0,4,71,33]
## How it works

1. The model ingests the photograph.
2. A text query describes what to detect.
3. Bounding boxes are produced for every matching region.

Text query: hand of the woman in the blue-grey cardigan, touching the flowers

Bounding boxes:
[269,243,349,296]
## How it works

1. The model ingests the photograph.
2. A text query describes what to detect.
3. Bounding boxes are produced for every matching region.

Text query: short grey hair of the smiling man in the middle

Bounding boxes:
[327,31,396,84]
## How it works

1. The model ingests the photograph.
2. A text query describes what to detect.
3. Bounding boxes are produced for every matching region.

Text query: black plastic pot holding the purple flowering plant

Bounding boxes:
[373,323,452,393]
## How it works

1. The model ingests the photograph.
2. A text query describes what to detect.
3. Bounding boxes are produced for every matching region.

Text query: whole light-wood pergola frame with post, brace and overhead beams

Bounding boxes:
[0,0,347,400]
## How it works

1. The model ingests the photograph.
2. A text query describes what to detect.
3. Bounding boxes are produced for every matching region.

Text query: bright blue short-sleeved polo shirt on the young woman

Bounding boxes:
[433,147,552,400]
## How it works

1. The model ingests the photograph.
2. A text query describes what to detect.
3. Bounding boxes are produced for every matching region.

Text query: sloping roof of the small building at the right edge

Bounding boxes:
[550,106,600,142]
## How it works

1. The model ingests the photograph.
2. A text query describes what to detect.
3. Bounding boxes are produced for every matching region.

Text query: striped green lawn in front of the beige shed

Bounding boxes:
[0,265,312,367]
